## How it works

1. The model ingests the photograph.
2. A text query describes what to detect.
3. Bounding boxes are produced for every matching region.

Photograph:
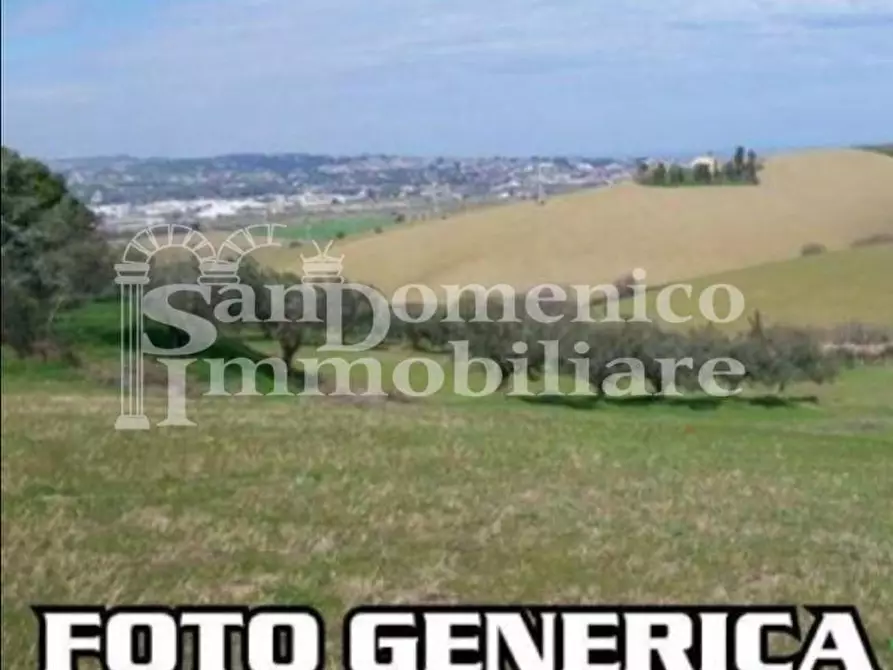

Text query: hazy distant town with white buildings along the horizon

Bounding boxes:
[51,154,640,230]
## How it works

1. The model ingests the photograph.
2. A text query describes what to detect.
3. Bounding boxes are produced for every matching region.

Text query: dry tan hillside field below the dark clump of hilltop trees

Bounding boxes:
[258,150,893,291]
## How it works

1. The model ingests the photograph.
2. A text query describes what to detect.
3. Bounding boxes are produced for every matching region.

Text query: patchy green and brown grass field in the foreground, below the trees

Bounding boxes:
[0,303,893,670]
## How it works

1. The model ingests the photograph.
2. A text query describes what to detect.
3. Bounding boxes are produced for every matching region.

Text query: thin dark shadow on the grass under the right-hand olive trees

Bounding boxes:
[517,395,819,411]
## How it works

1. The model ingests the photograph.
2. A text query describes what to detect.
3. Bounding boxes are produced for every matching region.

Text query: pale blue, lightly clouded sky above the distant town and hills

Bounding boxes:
[0,0,893,158]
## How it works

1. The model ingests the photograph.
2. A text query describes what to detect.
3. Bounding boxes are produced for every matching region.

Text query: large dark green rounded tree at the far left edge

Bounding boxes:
[0,147,114,356]
